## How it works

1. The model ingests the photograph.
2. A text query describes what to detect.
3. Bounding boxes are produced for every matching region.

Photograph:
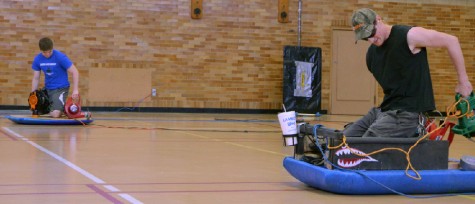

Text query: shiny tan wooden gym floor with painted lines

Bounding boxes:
[0,111,475,204]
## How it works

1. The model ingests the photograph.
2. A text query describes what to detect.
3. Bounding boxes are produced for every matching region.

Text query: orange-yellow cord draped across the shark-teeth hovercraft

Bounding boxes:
[327,97,470,180]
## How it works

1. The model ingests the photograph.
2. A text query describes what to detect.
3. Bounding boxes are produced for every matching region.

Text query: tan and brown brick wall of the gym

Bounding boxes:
[0,0,475,111]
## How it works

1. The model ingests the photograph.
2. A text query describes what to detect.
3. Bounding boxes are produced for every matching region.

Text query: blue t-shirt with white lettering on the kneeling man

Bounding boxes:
[31,49,73,89]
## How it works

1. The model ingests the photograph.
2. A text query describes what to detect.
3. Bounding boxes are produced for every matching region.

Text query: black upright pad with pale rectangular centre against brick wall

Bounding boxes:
[283,46,322,113]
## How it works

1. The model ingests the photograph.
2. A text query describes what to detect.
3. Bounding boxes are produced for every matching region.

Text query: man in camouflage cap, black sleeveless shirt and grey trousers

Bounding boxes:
[343,8,472,137]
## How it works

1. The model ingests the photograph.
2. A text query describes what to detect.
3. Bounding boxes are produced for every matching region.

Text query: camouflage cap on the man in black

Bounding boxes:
[351,8,376,41]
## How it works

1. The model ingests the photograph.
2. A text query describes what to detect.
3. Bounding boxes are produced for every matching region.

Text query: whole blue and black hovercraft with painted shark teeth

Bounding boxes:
[281,94,475,195]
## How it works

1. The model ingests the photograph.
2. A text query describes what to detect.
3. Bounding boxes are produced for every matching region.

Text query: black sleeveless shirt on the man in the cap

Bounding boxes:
[366,25,435,112]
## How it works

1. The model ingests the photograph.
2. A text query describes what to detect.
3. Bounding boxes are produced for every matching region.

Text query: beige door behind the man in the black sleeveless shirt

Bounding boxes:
[330,30,376,115]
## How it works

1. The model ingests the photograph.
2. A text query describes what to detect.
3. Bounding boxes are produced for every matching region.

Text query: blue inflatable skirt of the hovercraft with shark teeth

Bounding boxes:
[284,157,475,195]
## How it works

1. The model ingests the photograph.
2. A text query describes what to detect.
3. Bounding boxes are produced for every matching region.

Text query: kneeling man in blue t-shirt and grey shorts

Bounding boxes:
[31,37,79,118]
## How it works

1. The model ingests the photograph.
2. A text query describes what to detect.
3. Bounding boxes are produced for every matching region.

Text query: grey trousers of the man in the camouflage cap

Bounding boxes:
[343,108,419,137]
